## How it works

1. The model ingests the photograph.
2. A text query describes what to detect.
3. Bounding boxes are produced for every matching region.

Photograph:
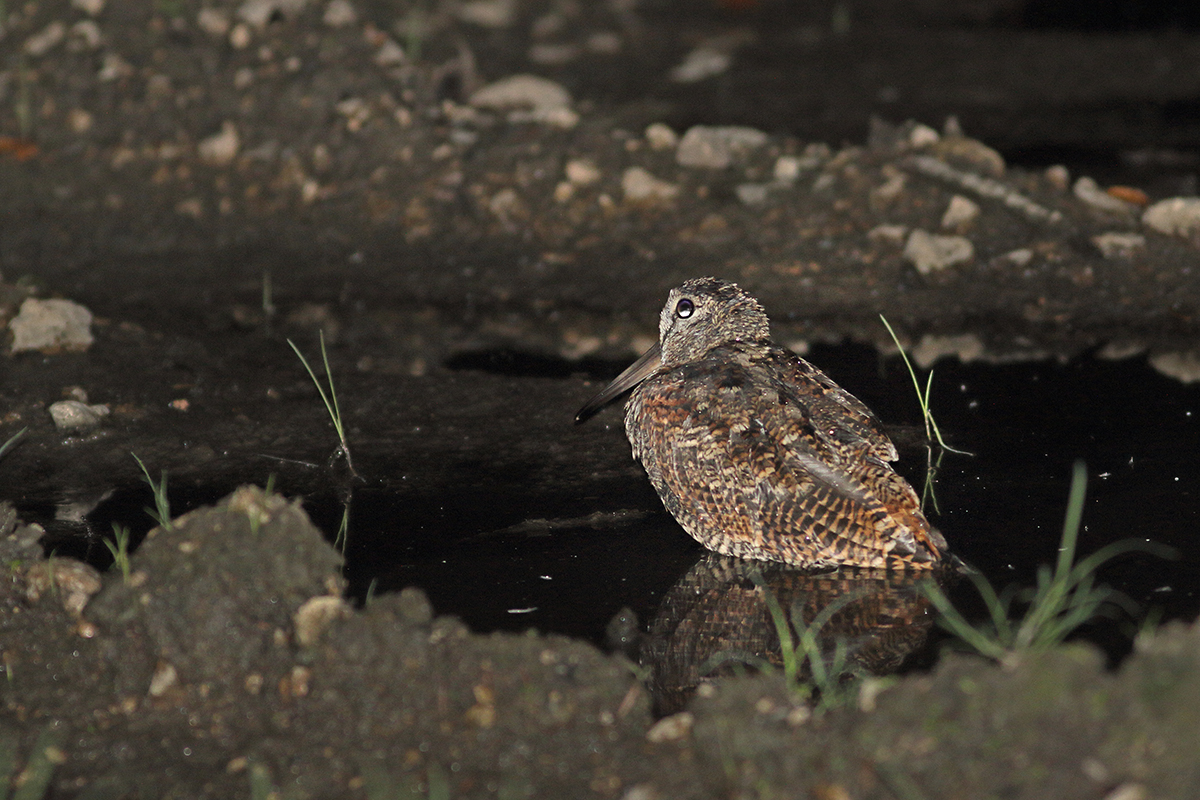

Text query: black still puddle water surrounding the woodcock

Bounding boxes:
[23,345,1200,657]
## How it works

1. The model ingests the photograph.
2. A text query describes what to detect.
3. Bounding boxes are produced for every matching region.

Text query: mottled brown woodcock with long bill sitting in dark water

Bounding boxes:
[576,278,947,570]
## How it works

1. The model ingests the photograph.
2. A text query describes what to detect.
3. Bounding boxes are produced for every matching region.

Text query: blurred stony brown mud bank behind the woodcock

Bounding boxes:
[0,0,1200,374]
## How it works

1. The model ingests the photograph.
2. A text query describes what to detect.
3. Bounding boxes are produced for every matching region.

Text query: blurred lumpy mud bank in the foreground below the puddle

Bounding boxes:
[0,488,1200,798]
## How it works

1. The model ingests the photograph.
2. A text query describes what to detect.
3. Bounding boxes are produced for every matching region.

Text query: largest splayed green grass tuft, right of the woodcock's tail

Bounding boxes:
[922,461,1175,663]
